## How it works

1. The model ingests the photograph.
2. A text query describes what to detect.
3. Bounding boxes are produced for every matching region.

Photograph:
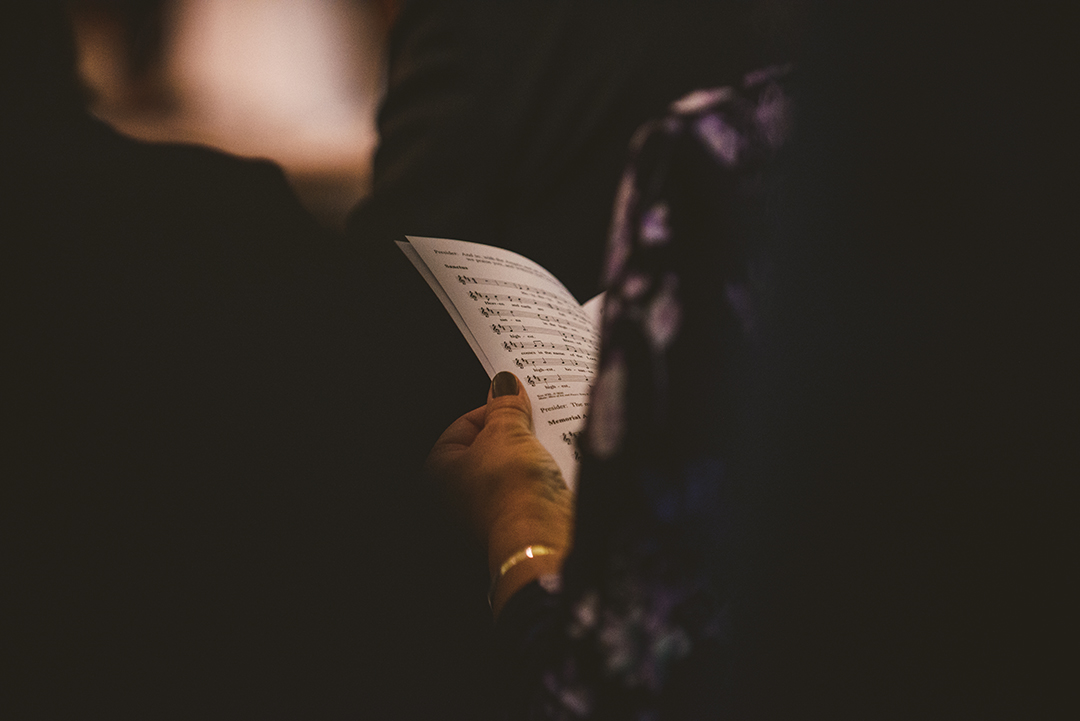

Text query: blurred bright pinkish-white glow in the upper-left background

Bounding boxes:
[168,0,381,169]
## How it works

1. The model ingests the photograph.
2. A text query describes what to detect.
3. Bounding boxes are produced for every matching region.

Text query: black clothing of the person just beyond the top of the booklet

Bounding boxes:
[350,0,748,301]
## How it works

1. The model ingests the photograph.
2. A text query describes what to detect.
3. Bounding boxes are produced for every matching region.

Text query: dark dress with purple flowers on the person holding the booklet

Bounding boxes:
[497,68,792,720]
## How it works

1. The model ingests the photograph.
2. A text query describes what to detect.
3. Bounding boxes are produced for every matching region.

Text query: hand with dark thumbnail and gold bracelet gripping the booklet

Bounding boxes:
[427,372,573,612]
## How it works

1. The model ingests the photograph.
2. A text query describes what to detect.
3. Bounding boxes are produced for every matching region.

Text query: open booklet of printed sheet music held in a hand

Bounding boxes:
[397,236,603,489]
